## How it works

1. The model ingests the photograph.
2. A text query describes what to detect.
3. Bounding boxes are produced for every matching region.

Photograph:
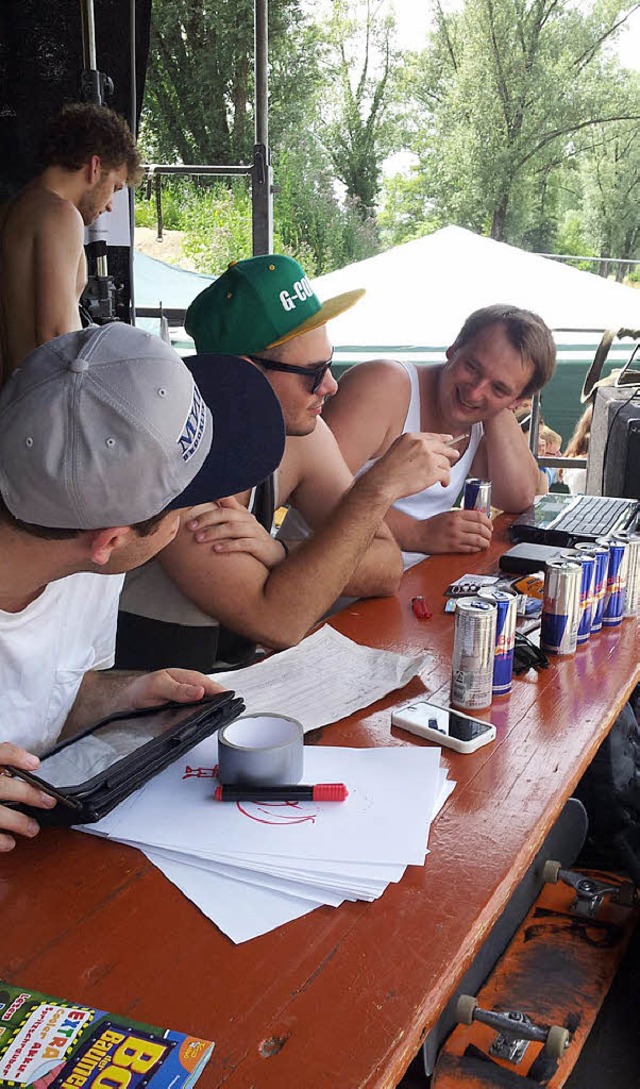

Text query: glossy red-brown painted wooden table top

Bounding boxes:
[0,519,640,1089]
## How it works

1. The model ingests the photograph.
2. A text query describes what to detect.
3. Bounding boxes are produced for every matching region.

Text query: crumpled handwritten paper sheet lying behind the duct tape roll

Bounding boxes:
[211,624,432,732]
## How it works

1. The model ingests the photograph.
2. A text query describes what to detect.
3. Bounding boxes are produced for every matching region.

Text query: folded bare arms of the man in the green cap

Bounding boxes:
[170,426,457,649]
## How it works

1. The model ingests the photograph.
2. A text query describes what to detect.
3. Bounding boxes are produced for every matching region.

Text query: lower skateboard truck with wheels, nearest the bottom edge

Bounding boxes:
[455,994,570,1065]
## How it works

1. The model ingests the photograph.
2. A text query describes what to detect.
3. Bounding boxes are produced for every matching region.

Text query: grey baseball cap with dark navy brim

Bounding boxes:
[0,322,284,529]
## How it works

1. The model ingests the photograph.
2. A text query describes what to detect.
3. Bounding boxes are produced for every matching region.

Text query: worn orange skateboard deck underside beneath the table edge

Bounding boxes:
[431,864,639,1089]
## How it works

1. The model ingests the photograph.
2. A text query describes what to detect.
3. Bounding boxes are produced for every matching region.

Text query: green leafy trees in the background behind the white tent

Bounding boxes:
[141,0,640,274]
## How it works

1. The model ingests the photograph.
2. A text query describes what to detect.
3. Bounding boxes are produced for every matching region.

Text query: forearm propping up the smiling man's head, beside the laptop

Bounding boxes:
[471,408,549,514]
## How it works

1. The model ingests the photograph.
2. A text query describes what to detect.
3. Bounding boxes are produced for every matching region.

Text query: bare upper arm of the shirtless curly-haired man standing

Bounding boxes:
[34,200,84,344]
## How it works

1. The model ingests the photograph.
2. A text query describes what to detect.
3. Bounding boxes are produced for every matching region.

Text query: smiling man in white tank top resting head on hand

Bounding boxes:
[323,305,555,553]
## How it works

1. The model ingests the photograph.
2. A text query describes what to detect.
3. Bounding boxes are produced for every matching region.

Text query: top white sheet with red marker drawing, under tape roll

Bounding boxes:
[87,737,440,865]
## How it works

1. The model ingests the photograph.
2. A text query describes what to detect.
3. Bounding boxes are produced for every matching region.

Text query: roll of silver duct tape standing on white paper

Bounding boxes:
[218,714,304,786]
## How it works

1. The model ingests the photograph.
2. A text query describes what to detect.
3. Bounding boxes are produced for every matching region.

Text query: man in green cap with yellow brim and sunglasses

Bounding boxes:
[118,254,458,668]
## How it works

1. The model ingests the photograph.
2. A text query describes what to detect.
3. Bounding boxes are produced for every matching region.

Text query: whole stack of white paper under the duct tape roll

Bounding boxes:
[83,737,454,942]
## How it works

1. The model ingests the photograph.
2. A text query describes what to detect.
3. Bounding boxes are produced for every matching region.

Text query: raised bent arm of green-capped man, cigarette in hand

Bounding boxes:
[159,428,455,649]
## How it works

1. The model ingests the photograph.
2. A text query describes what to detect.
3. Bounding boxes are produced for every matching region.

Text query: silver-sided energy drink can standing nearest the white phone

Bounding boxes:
[451,598,496,711]
